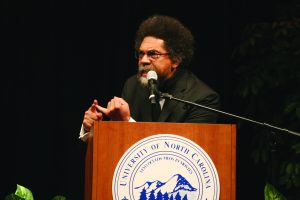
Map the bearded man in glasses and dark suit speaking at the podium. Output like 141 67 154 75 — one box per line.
80 15 220 140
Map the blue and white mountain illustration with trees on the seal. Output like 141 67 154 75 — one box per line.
134 174 197 199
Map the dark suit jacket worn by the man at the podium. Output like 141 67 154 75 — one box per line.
122 69 220 123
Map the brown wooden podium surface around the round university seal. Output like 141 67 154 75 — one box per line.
85 121 236 200
